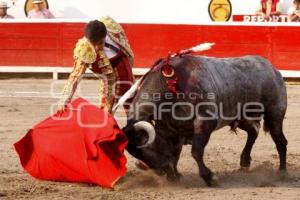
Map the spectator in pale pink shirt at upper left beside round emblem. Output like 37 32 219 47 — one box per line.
28 0 55 19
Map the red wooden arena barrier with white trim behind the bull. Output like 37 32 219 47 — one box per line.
0 19 300 79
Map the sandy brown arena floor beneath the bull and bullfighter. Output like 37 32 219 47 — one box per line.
0 79 300 200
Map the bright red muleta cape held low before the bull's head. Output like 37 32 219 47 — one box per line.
14 98 127 188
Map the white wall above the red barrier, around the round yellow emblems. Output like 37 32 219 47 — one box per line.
7 0 293 24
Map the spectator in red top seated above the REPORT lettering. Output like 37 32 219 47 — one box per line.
256 0 281 18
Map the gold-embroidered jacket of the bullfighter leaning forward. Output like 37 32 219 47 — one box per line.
61 17 134 113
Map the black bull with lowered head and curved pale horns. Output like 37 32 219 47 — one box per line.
124 55 287 186
